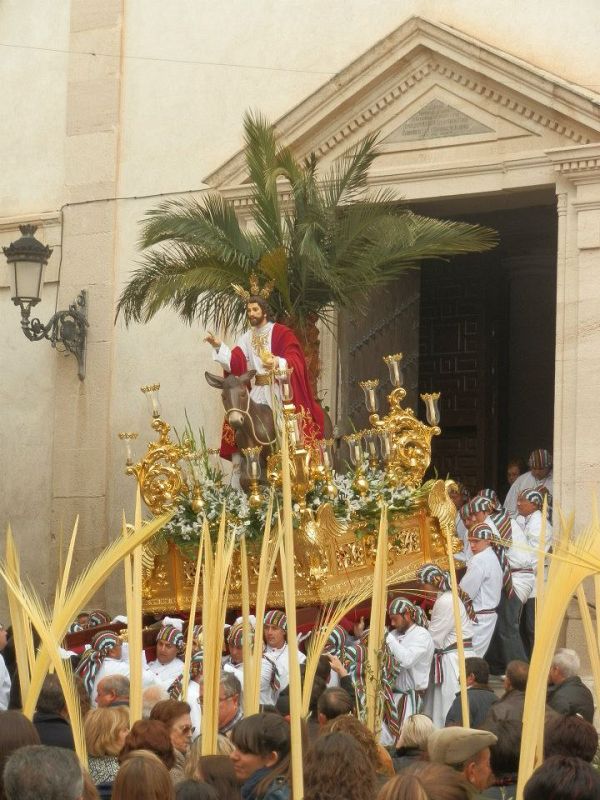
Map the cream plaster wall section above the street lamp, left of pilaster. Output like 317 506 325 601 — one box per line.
0 0 69 217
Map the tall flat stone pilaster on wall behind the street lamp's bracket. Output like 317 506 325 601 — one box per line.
51 0 123 610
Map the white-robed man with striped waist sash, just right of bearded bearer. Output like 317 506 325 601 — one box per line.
417 564 477 728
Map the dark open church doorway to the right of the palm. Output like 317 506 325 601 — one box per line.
419 203 557 491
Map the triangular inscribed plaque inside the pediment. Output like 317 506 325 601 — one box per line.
384 100 492 142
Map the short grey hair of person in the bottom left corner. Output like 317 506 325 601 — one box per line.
4 744 83 800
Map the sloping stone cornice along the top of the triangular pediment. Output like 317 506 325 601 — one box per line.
205 17 600 188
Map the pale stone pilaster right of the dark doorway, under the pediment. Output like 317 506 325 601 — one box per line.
547 144 600 526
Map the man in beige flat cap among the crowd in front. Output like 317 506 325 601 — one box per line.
427 726 498 792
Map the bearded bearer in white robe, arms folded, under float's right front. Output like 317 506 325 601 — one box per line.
386 597 434 726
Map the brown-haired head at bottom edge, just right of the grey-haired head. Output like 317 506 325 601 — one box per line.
112 752 175 800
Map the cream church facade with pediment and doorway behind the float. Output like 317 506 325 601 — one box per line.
0 0 600 611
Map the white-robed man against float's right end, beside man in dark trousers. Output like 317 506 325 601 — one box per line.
459 522 510 658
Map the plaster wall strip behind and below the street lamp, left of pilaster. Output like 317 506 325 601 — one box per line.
0 226 61 622
